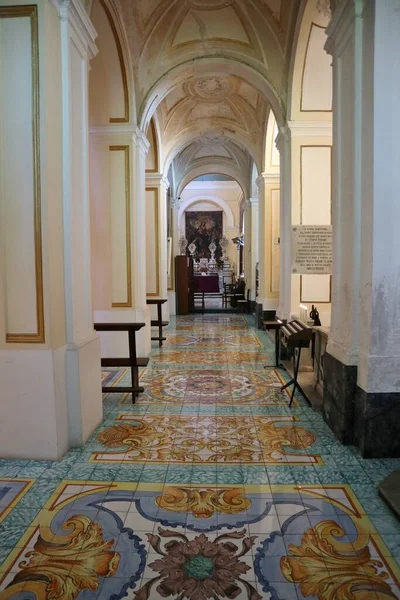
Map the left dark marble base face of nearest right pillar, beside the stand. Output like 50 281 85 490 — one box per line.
323 352 357 444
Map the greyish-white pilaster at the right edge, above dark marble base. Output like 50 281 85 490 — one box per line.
358 0 400 396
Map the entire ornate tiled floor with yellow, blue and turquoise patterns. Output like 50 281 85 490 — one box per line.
0 315 400 600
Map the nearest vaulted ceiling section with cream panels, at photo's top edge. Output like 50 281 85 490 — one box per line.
120 0 301 118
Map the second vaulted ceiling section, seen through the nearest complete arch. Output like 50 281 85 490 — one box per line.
157 74 268 172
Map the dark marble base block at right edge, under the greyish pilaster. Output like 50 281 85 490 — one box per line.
354 387 400 458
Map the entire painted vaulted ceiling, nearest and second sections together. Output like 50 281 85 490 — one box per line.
95 0 304 182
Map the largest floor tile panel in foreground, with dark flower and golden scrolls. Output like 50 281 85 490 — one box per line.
0 481 400 600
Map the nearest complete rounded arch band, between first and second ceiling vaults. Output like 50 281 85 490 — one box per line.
139 56 285 130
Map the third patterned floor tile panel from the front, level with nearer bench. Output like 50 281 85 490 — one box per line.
134 369 297 406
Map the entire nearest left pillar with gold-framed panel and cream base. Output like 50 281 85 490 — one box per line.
0 0 102 459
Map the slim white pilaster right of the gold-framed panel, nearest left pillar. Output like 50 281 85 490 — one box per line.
60 0 102 445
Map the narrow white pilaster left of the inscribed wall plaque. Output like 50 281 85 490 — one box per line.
276 125 292 320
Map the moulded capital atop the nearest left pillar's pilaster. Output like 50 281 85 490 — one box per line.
50 0 98 60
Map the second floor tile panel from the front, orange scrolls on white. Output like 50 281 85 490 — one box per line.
90 414 323 465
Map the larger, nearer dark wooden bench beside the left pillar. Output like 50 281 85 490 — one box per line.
93 323 149 404
